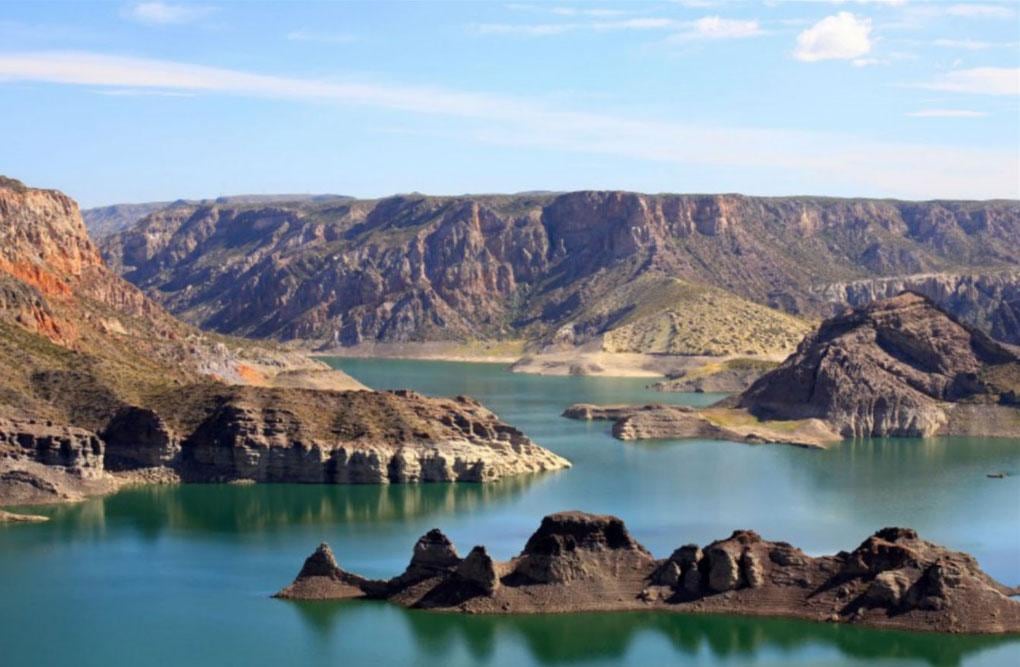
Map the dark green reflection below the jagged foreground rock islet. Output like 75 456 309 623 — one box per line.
285 601 1020 667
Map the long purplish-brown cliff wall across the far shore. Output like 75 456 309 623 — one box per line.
103 192 1020 345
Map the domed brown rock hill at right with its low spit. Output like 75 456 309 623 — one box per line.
564 292 1020 446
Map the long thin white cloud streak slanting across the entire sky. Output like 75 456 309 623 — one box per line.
0 51 1020 197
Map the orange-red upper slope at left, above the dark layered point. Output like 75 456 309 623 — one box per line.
0 178 359 429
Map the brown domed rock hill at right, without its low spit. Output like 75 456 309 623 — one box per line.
737 293 1020 437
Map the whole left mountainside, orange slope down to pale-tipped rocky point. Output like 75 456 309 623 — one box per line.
0 177 568 504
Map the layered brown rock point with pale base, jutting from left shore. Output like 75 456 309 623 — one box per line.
178 388 569 483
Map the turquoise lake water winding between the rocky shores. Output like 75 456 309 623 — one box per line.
0 360 1020 667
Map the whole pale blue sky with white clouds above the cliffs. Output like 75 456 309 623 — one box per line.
0 0 1020 207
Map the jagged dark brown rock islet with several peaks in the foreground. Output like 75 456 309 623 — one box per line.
277 512 1020 633
